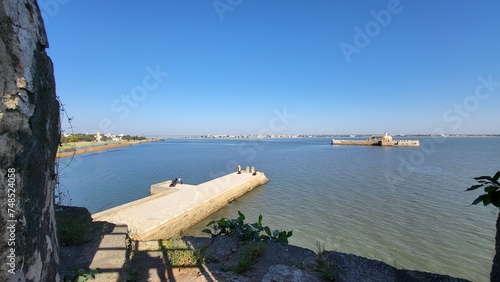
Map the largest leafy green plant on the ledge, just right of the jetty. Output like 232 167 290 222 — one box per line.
202 211 293 245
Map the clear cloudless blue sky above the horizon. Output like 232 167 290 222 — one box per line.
39 0 500 135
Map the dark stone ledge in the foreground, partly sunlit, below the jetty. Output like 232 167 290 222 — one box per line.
56 207 467 282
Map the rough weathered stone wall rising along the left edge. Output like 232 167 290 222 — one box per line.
0 0 60 281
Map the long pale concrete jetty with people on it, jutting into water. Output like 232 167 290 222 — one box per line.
92 169 269 241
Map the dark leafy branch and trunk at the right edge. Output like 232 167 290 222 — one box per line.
467 171 500 281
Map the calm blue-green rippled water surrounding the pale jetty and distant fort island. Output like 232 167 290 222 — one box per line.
60 138 500 281
